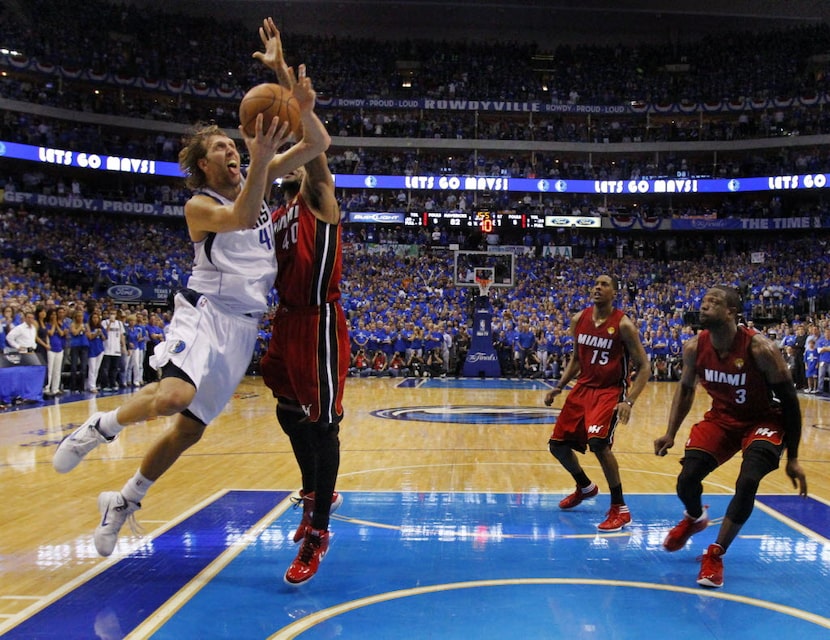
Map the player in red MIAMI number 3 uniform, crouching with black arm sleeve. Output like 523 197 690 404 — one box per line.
654 286 807 587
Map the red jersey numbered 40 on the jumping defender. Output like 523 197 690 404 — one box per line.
272 194 343 307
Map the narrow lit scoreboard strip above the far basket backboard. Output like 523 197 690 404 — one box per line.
404 210 602 233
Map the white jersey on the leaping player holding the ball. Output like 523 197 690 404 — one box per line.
187 182 277 314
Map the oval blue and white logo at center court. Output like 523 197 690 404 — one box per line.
372 405 559 424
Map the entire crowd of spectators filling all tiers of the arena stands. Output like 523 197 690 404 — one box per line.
0 0 830 396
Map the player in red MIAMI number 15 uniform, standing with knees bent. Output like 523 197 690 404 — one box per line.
545 275 649 531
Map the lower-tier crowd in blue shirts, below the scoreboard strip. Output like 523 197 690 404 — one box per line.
0 199 830 396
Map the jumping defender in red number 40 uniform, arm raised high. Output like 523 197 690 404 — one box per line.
255 18 349 585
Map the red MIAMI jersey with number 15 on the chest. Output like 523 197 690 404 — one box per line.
574 307 629 388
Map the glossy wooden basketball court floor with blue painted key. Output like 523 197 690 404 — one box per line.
0 377 830 640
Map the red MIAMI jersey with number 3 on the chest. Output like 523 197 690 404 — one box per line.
695 325 780 423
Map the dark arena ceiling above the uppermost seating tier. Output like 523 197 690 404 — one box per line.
138 0 830 48
